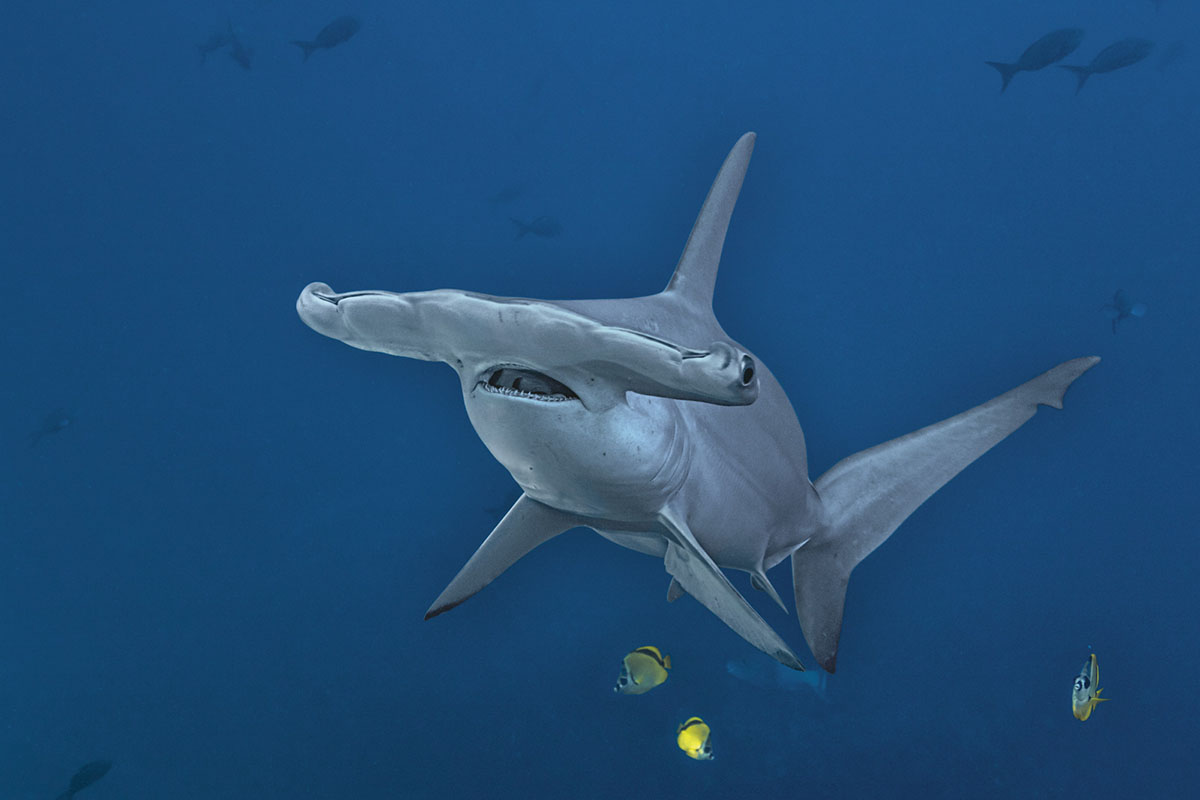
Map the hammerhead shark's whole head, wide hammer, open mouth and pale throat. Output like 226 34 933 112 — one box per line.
296 283 758 519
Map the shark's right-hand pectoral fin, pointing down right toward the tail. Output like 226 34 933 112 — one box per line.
659 515 804 670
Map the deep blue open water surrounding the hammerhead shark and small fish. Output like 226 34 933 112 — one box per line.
0 0 1200 800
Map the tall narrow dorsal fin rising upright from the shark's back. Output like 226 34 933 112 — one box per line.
666 133 755 309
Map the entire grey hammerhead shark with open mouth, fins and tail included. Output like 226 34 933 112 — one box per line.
296 133 1099 672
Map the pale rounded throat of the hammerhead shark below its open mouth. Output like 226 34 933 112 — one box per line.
463 386 690 520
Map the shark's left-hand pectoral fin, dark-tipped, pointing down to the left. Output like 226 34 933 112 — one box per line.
425 494 582 619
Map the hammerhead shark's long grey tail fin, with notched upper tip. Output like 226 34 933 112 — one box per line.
792 356 1099 672
